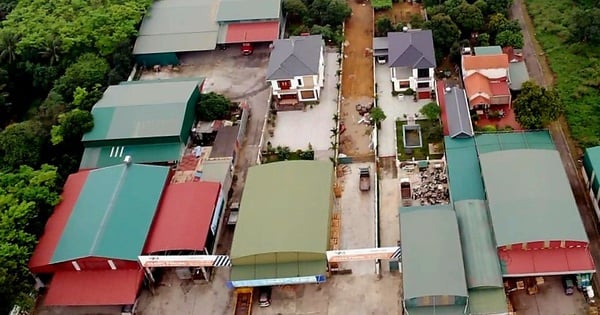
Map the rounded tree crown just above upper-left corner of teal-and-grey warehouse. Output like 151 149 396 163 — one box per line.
53 53 110 102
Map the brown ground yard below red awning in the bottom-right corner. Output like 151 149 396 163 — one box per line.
510 276 586 315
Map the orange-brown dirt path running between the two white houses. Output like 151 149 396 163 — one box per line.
340 0 374 159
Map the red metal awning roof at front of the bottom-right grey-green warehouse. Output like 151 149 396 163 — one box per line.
498 247 595 276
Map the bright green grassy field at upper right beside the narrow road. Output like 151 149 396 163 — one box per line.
526 0 600 147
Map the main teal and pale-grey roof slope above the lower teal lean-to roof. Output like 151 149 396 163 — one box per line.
82 79 203 143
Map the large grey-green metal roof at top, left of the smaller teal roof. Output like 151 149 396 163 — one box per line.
133 0 219 55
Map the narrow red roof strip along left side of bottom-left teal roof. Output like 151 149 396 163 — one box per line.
29 171 90 273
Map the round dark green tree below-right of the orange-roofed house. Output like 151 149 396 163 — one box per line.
513 81 564 129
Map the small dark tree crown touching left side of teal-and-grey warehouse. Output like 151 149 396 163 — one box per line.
50 108 94 145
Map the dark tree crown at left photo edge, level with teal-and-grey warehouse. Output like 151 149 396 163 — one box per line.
0 120 47 169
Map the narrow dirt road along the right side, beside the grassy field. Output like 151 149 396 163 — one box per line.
511 0 600 287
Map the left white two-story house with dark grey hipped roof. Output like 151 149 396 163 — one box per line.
267 35 325 110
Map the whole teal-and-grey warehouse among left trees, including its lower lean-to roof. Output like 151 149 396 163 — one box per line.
79 79 203 169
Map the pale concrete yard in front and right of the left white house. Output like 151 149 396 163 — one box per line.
265 48 339 160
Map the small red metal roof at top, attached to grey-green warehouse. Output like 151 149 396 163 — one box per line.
225 22 279 44
